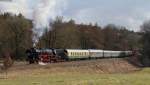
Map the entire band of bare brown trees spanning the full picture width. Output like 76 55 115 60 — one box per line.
0 13 150 66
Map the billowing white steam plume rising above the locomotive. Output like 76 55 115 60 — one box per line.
33 0 66 34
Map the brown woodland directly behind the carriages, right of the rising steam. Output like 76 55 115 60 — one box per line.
37 17 141 50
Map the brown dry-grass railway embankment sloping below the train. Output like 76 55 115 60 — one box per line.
9 58 140 73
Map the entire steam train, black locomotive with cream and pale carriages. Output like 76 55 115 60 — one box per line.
26 48 133 64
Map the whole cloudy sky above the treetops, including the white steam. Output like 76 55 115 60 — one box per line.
0 0 150 31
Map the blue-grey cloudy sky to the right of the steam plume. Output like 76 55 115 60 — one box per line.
64 0 150 31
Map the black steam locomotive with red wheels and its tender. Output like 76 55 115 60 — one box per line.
26 48 68 64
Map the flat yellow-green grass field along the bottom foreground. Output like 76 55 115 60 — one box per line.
0 68 150 85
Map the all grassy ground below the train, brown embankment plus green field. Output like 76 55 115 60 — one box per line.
0 59 146 85
